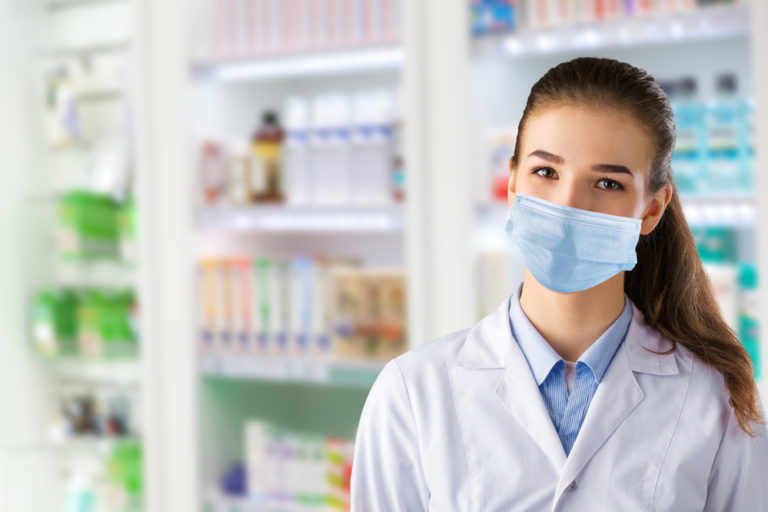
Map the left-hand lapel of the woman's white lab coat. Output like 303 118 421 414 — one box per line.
457 296 565 473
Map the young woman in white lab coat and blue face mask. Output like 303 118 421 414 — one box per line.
352 58 768 512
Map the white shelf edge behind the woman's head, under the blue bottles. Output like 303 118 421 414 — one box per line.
477 196 757 229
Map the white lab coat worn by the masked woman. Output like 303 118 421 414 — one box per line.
351 296 768 512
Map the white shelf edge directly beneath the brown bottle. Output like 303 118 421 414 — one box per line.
195 205 404 233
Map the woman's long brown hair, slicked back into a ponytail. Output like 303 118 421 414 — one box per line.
512 57 763 436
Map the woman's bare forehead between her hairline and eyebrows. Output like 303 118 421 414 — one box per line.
520 105 653 172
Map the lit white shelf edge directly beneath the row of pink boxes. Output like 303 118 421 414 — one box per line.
192 46 404 82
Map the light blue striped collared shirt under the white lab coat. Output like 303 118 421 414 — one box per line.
509 284 632 454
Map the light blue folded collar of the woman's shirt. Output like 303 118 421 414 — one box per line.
509 284 632 386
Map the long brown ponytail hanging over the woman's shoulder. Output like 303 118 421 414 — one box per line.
624 190 763 436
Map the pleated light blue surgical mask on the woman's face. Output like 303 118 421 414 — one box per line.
505 194 642 293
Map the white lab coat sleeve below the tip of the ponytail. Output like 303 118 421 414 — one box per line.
704 410 768 512
